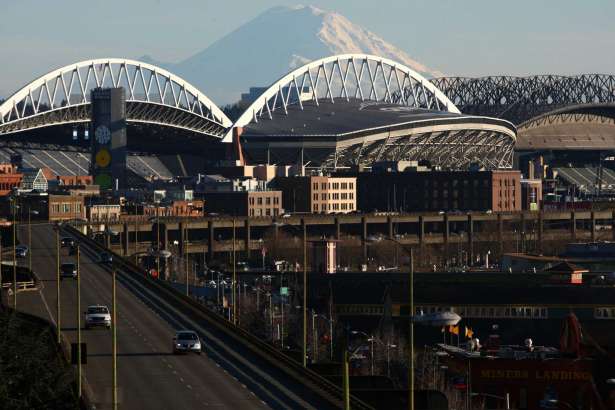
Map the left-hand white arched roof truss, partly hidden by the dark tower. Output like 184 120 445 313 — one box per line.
0 59 231 139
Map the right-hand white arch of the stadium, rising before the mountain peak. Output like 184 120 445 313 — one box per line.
223 54 460 142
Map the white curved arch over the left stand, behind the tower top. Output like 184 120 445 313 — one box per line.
0 58 232 133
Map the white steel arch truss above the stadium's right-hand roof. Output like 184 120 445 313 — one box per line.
227 54 459 139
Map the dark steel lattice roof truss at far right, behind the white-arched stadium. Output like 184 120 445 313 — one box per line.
430 74 615 125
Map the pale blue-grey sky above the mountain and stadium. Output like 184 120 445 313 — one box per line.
0 0 615 98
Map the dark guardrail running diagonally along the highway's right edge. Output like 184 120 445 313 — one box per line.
65 225 373 410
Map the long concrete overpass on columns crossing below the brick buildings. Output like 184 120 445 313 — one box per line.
86 210 615 268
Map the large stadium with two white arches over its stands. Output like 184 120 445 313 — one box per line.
0 54 516 179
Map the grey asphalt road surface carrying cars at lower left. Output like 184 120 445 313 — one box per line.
18 225 278 409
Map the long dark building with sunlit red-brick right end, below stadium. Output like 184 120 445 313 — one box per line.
357 170 521 212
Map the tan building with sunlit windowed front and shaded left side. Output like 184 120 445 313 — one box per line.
272 176 357 214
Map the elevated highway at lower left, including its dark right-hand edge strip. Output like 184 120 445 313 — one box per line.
18 225 368 409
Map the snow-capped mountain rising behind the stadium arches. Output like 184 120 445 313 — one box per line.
142 6 441 106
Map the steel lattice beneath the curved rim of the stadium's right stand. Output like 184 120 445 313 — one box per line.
322 129 514 170
